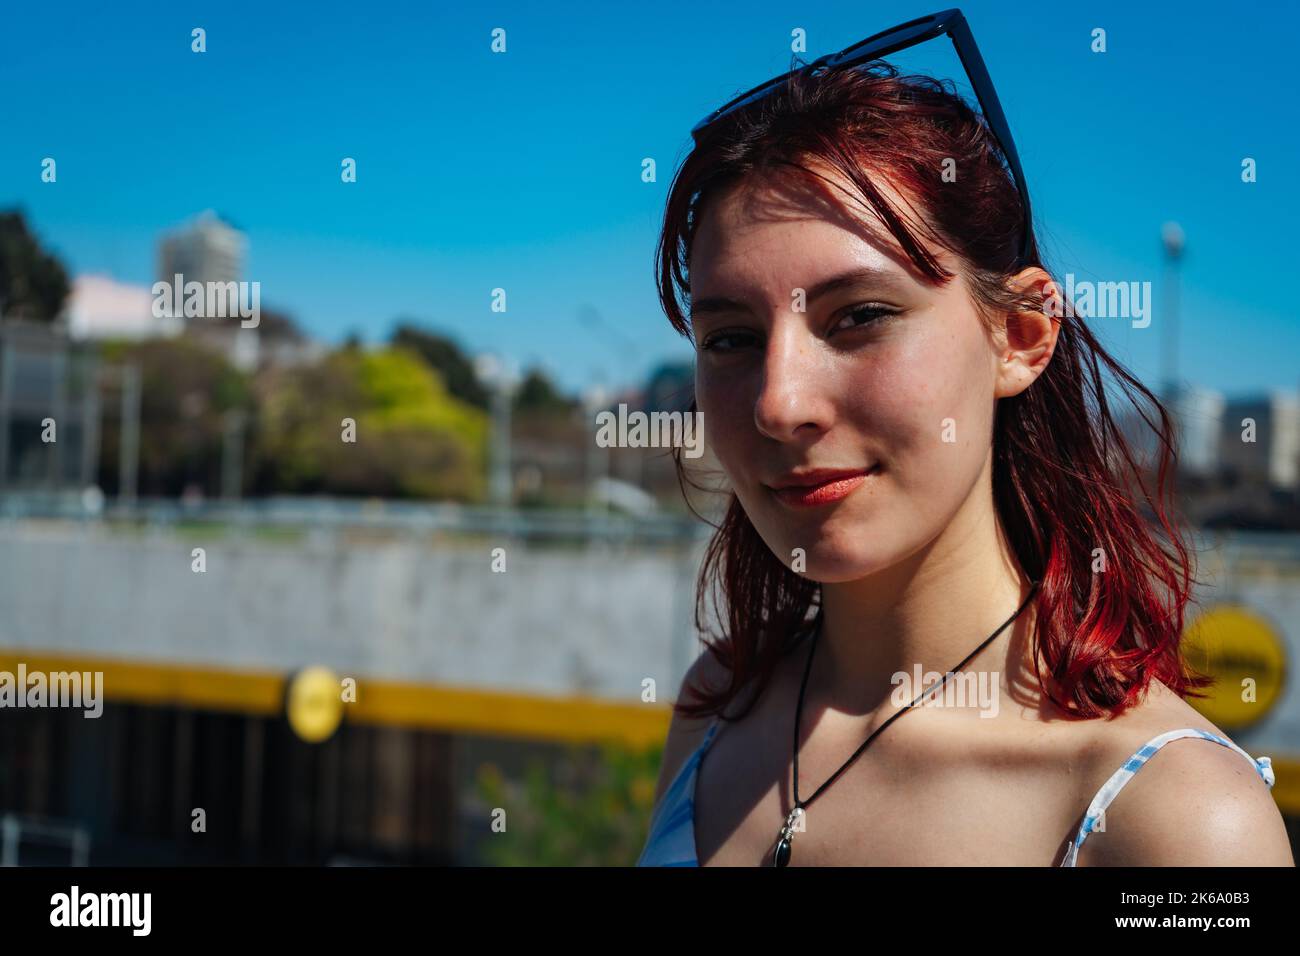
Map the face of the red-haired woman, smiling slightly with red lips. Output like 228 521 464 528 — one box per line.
689 165 1019 583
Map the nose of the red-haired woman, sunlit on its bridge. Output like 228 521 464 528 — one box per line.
754 326 831 441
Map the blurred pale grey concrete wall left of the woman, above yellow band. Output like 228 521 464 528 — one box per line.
0 522 702 701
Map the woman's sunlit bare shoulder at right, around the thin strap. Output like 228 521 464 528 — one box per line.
1079 682 1295 866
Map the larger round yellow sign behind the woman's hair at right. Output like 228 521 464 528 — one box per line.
1183 605 1287 730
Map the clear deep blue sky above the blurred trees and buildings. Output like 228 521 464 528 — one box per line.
0 0 1300 393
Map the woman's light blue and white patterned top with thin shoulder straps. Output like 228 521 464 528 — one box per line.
637 721 1274 866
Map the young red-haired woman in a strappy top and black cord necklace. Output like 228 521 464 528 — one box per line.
640 50 1295 866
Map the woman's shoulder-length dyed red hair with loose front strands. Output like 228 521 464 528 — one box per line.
655 61 1212 718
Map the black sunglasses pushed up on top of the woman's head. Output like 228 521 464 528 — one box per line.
690 8 1032 264
